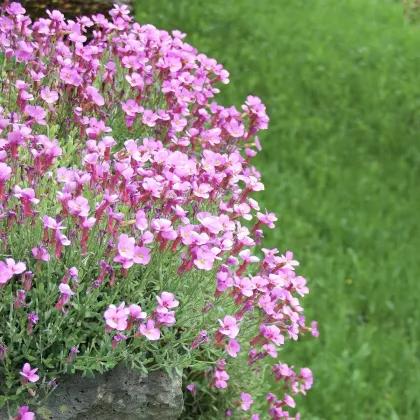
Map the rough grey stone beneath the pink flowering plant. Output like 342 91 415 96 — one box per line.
0 367 184 420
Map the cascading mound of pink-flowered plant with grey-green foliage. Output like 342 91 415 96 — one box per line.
0 3 318 420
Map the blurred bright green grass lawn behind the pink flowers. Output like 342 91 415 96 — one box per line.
137 0 420 420
